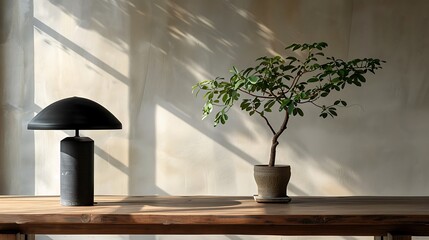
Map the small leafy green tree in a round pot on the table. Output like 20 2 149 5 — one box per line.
192 42 384 202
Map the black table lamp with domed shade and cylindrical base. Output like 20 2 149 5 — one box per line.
28 97 122 206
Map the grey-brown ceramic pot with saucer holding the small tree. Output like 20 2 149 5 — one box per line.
254 165 291 202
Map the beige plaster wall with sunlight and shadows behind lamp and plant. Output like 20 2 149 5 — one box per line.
0 0 429 239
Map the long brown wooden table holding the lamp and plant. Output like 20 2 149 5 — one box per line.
0 196 429 240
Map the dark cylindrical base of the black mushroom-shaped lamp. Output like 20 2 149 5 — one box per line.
60 136 94 206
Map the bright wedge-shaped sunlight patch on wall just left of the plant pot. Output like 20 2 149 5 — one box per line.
155 105 255 195
